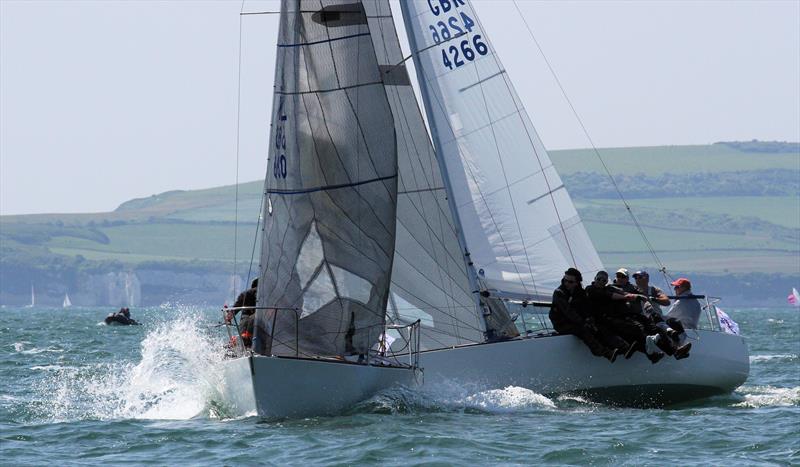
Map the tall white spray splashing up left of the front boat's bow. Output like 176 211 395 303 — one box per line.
37 310 238 422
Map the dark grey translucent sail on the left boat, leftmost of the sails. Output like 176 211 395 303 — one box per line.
253 0 397 356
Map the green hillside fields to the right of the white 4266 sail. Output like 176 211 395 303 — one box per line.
551 142 800 275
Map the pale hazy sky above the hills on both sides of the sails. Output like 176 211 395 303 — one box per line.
0 0 800 215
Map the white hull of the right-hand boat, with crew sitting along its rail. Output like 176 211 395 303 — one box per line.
420 331 750 406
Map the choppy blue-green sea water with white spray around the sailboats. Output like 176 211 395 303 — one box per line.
0 307 800 465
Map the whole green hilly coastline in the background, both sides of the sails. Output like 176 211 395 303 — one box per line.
0 142 800 302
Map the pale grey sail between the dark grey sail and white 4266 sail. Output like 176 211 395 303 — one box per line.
364 0 484 349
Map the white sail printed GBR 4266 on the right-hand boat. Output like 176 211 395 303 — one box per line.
401 0 602 297
